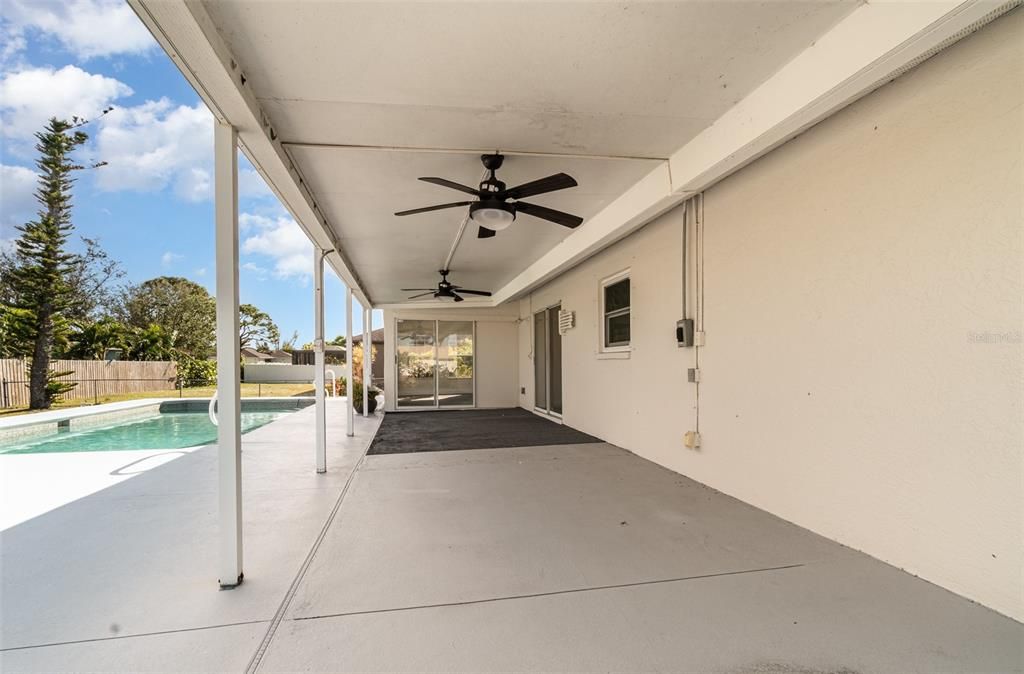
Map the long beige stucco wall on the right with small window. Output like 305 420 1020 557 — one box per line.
518 10 1024 620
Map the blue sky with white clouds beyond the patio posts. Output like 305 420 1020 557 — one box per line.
0 0 381 343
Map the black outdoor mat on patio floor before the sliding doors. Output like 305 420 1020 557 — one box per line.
367 408 601 454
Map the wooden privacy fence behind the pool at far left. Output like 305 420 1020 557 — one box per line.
0 359 178 408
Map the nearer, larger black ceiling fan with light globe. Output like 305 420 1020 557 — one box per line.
395 154 583 239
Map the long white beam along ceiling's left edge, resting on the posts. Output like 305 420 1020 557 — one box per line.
127 0 370 305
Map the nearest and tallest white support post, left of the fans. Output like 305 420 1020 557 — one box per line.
213 123 243 588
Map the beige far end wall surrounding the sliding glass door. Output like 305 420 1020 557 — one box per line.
384 305 518 410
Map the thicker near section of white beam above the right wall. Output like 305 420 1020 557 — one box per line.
669 0 1020 194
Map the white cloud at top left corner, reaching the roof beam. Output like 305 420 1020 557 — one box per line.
3 0 157 58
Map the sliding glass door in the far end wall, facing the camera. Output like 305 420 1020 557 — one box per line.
396 320 475 409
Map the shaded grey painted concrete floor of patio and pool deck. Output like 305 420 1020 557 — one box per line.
0 401 1024 673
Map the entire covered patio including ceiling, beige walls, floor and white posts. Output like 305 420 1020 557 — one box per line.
0 0 1024 673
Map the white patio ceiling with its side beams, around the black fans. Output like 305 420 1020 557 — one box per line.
130 0 998 306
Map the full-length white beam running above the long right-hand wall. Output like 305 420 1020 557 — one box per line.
491 0 1020 301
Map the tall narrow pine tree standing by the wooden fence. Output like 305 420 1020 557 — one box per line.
8 118 88 410
